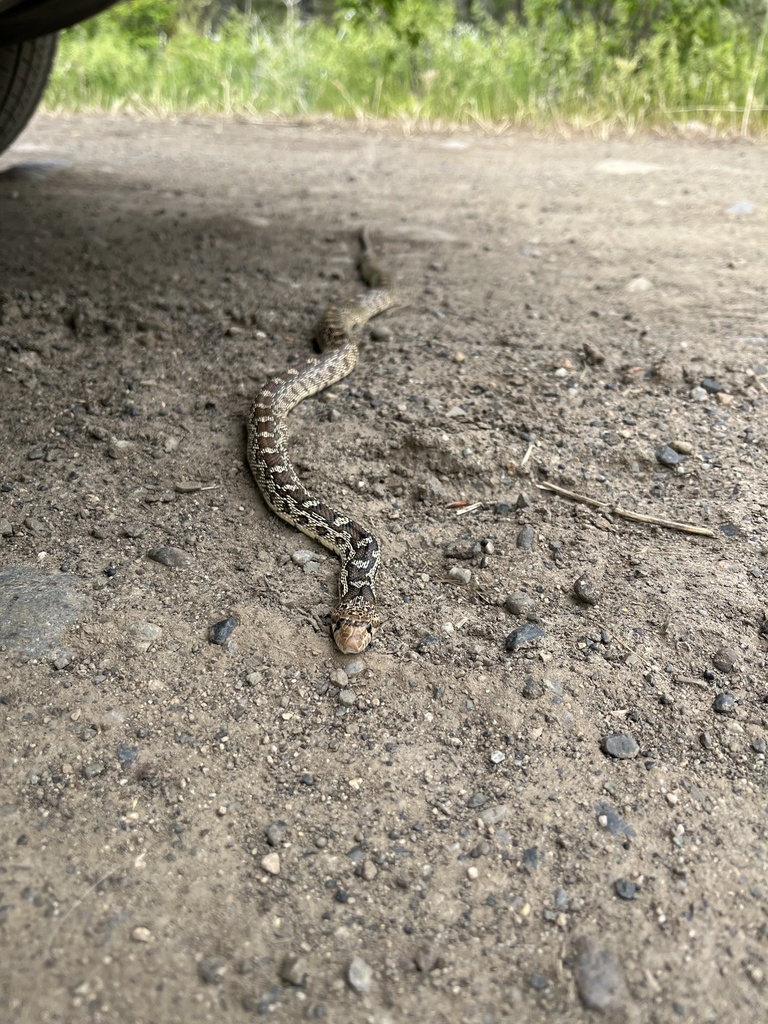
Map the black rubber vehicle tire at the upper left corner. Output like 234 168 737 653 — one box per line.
0 36 56 153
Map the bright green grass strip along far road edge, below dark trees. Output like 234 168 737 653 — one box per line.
45 7 768 133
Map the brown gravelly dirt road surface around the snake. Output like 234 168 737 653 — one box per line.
0 117 768 1024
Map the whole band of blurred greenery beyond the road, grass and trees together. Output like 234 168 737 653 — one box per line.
47 0 768 133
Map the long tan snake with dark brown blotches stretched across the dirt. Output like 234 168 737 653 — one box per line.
248 228 395 654
